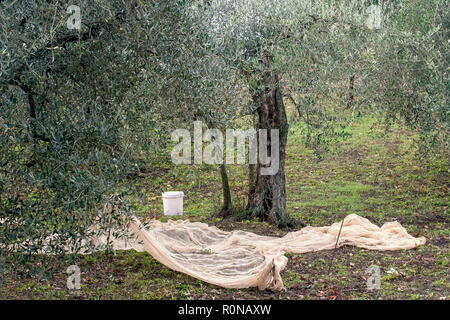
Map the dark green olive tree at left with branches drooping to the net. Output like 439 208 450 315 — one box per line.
0 0 202 253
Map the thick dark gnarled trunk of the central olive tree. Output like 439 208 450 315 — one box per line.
247 52 291 226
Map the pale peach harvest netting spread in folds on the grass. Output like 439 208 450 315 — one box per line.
114 214 426 290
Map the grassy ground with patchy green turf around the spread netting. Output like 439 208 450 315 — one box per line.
0 115 450 299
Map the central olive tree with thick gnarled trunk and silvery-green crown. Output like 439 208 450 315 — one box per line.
192 1 380 225
